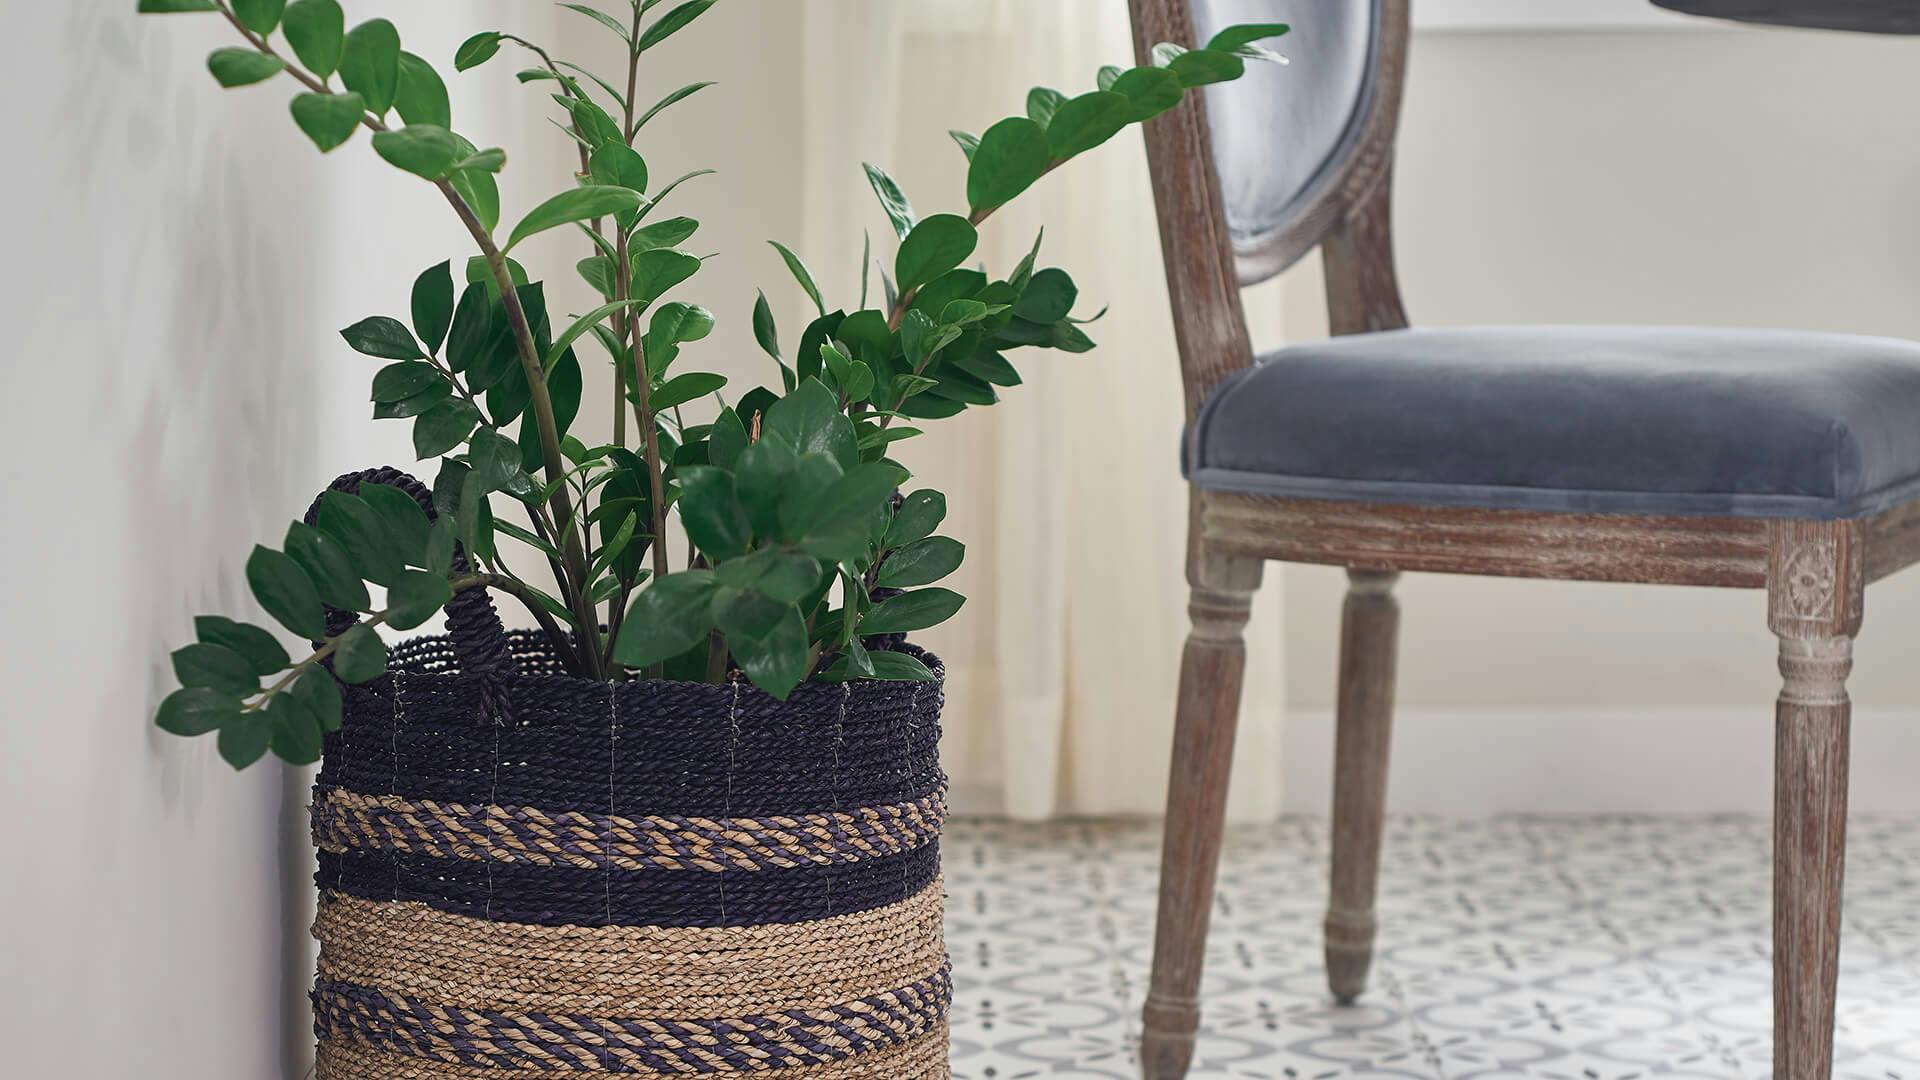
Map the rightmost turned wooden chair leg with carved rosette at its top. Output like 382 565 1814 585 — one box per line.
1766 521 1862 1080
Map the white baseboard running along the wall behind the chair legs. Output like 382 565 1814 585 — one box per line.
1283 707 1920 817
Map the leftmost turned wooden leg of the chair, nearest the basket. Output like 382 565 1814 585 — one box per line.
1140 552 1263 1080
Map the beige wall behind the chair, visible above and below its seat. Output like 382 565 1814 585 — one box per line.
1284 29 1920 711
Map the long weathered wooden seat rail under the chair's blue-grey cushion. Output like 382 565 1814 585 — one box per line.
1200 492 1766 588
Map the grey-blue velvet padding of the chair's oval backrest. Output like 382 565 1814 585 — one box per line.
1192 0 1380 276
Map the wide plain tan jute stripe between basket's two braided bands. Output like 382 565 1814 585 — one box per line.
313 880 947 1019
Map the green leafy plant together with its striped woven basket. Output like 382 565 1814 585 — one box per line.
140 0 1286 1080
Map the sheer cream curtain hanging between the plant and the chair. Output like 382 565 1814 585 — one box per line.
801 0 1284 821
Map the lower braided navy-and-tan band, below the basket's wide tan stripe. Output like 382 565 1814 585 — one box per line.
313 967 952 1072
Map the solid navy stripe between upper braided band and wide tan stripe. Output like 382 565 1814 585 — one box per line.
313 842 941 926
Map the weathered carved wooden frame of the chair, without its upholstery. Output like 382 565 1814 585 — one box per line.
1131 0 1920 1080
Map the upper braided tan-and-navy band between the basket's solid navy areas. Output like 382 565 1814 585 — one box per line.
313 788 947 871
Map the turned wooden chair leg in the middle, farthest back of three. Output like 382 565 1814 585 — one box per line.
1327 571 1400 1005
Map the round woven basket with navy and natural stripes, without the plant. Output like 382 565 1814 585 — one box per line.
313 471 950 1080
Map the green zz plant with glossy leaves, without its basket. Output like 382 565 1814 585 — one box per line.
140 0 1286 769
